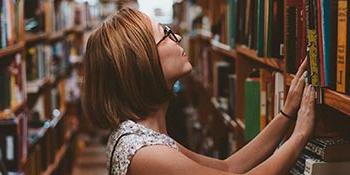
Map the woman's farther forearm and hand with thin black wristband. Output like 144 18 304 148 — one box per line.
226 59 307 173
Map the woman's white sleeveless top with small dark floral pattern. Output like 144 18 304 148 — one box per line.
106 120 178 175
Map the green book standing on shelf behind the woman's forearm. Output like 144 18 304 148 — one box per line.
244 78 260 141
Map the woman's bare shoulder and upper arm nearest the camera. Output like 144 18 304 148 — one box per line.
128 145 242 175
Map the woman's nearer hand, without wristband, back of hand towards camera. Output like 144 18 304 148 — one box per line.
293 85 315 139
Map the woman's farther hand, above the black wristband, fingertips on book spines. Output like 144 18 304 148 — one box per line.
283 58 307 116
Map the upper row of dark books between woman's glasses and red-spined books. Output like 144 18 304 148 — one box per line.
197 0 284 58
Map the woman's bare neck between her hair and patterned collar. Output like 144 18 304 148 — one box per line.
137 102 169 134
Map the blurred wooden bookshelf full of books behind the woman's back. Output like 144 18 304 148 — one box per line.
0 0 105 175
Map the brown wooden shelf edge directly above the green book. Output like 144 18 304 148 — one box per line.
236 45 284 72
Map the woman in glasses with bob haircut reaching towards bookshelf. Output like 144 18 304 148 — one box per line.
83 9 315 175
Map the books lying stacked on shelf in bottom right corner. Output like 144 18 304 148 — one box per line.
290 137 350 175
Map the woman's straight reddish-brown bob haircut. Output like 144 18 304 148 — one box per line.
82 8 172 128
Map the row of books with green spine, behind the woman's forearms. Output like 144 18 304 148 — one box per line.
213 61 284 140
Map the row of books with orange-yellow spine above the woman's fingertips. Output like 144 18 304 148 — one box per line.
285 0 350 94
